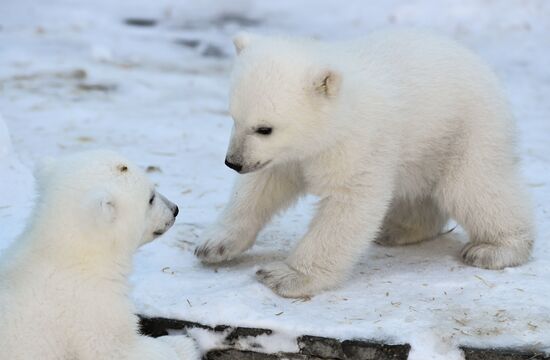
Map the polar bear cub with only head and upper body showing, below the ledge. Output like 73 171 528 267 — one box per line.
0 151 200 360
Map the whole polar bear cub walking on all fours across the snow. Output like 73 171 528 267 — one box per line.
196 30 533 297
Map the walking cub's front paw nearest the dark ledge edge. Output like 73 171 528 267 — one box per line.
256 261 319 298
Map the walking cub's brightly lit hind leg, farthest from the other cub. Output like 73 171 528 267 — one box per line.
438 161 534 269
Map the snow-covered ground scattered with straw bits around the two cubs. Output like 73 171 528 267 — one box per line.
0 0 550 359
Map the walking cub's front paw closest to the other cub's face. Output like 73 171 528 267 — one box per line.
195 229 253 264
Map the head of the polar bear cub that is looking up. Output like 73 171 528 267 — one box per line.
31 150 178 252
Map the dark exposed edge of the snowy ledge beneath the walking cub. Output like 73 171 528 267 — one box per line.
140 316 550 360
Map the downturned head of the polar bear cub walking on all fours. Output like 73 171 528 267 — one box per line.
225 34 341 173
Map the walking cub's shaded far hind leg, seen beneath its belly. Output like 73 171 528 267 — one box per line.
376 197 448 246
